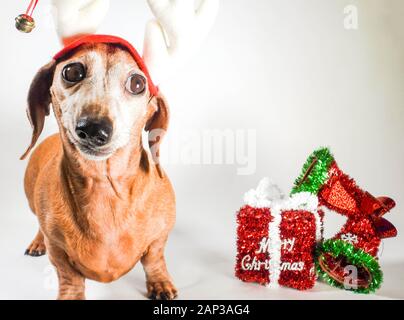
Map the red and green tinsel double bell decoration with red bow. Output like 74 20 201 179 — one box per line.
292 148 397 293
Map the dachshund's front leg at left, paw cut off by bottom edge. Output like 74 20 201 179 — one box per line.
48 245 85 300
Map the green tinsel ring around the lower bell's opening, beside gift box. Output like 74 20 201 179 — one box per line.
316 239 383 293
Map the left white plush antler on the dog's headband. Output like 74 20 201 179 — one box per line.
52 0 109 41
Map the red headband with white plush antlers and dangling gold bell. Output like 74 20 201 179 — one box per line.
16 0 219 90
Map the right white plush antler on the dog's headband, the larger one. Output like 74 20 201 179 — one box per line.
143 0 219 84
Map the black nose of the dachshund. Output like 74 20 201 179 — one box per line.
76 118 112 147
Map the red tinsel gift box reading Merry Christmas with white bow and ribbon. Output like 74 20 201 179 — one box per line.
235 178 322 290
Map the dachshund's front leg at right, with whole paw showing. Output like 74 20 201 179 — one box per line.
141 238 177 300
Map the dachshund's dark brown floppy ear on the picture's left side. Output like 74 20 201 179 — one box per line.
20 60 56 160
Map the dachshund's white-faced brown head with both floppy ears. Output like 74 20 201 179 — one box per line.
22 36 168 172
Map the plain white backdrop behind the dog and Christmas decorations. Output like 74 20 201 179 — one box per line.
0 0 404 299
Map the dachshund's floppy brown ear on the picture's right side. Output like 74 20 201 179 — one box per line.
145 94 170 178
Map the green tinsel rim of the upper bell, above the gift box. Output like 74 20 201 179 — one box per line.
291 148 334 195
